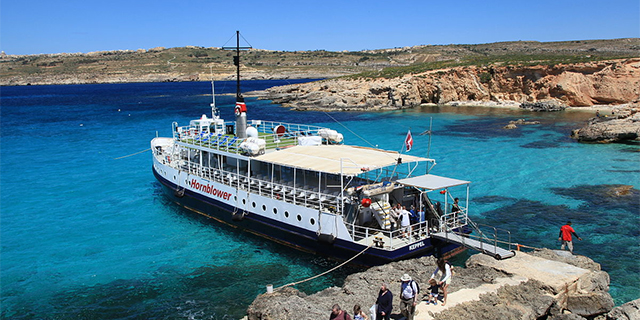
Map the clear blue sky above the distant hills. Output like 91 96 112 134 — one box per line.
0 0 640 54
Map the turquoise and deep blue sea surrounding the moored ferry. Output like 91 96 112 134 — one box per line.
0 80 640 319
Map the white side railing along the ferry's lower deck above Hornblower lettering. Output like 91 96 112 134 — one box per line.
178 163 342 214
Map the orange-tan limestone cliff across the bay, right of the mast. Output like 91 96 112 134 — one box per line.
266 58 640 110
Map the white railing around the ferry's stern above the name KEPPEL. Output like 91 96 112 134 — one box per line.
347 221 437 250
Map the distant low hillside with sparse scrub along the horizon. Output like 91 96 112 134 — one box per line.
0 38 640 83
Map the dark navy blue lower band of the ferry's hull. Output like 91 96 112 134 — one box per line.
153 168 459 266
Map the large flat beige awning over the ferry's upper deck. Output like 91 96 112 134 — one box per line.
254 145 431 175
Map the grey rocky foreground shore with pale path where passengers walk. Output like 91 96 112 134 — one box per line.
246 249 640 320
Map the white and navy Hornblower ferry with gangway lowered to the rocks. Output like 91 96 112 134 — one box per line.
151 31 515 266
